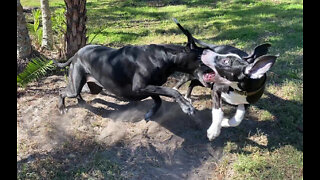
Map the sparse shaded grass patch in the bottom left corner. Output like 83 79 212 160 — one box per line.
17 152 121 179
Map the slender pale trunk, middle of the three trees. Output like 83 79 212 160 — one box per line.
40 0 53 50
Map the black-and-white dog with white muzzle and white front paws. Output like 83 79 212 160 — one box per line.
172 22 277 140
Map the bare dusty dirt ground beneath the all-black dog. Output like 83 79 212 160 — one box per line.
17 75 239 179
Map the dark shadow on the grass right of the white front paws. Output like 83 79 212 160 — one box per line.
214 92 303 154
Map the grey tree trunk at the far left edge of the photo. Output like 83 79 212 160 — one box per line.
17 0 32 59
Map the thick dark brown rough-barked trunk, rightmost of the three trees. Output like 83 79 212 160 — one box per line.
64 0 87 59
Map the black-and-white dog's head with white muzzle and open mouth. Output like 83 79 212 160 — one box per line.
201 45 277 88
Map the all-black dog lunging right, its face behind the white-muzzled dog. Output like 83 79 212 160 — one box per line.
55 22 203 120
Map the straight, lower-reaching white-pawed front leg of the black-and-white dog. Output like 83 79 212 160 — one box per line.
207 86 223 141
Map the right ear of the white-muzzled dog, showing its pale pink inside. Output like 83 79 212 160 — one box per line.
244 55 277 79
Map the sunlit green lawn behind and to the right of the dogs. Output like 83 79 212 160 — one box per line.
21 0 303 179
